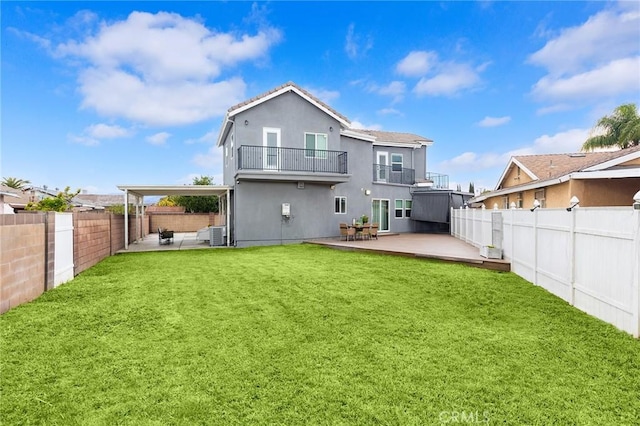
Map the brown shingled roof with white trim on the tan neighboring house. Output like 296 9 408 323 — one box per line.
472 145 640 202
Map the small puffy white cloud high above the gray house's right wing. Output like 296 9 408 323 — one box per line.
413 62 480 96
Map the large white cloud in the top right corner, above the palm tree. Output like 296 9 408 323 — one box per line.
528 2 640 106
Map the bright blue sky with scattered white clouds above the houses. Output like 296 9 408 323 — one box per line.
0 1 640 193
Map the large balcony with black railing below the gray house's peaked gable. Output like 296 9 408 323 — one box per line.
236 145 351 184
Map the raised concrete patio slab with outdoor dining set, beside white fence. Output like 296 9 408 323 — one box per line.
307 234 511 271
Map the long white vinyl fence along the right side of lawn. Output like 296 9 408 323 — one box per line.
451 207 640 337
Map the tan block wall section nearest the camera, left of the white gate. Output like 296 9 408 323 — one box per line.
0 213 45 313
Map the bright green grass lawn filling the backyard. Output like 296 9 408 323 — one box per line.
0 245 640 425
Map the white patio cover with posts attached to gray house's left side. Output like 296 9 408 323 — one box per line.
118 185 232 250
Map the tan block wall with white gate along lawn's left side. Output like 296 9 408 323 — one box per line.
0 212 149 314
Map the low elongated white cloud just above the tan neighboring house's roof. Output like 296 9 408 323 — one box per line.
438 129 589 173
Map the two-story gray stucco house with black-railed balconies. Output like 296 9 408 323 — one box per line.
218 83 448 247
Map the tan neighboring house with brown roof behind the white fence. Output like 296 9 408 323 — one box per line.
471 146 640 209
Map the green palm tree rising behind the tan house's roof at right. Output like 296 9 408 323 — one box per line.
582 104 640 151
